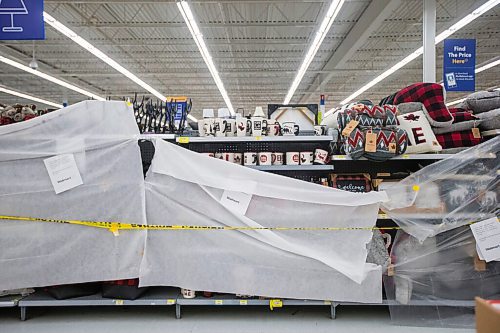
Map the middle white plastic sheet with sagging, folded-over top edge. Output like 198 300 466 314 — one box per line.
140 141 387 302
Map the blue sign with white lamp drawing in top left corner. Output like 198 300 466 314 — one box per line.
0 0 45 40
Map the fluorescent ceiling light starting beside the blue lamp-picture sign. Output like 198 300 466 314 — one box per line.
43 12 197 121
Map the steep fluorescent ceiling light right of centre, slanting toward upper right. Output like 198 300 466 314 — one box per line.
283 0 344 104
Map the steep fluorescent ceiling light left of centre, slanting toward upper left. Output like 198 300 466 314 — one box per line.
177 0 235 116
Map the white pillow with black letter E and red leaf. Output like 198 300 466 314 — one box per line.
398 111 442 154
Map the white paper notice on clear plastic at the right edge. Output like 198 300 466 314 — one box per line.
470 217 500 262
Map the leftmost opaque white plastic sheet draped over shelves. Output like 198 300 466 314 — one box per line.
0 101 146 290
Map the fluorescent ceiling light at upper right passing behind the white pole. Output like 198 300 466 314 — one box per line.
340 0 500 104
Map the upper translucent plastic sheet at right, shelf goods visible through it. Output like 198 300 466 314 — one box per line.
382 137 500 242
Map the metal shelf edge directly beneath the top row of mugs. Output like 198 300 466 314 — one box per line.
176 135 333 143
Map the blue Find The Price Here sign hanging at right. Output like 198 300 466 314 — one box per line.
443 39 476 91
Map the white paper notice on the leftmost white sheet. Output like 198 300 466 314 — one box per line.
43 154 83 194
